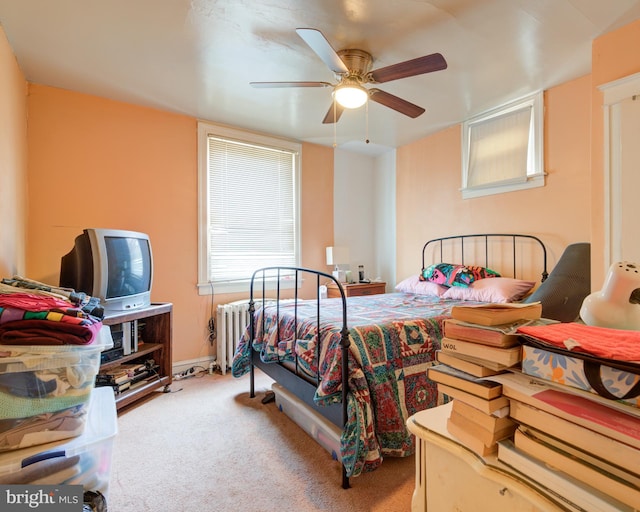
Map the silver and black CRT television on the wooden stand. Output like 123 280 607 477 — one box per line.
60 228 153 315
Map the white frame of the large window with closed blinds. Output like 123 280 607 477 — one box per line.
197 121 302 295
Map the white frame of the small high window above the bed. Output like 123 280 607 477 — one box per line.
461 91 545 199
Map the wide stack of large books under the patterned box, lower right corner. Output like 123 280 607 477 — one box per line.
495 372 640 511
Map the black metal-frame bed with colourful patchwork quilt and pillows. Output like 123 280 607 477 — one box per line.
232 234 548 488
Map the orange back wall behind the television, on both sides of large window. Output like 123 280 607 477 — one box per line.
27 85 333 361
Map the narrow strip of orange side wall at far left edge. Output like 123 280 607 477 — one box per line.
0 26 27 277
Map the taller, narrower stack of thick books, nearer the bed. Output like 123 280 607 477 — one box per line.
427 303 542 457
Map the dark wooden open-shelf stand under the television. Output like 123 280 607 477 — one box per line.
100 302 173 410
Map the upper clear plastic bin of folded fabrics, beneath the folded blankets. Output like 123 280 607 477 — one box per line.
0 328 113 452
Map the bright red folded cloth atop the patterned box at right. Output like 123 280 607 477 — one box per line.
518 322 640 361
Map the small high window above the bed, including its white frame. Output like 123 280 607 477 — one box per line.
462 93 544 199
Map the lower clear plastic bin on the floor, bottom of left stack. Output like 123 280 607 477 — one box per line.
0 388 118 497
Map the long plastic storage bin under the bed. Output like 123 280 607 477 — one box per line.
271 384 342 461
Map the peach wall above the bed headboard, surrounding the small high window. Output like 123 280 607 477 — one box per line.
396 76 591 280
